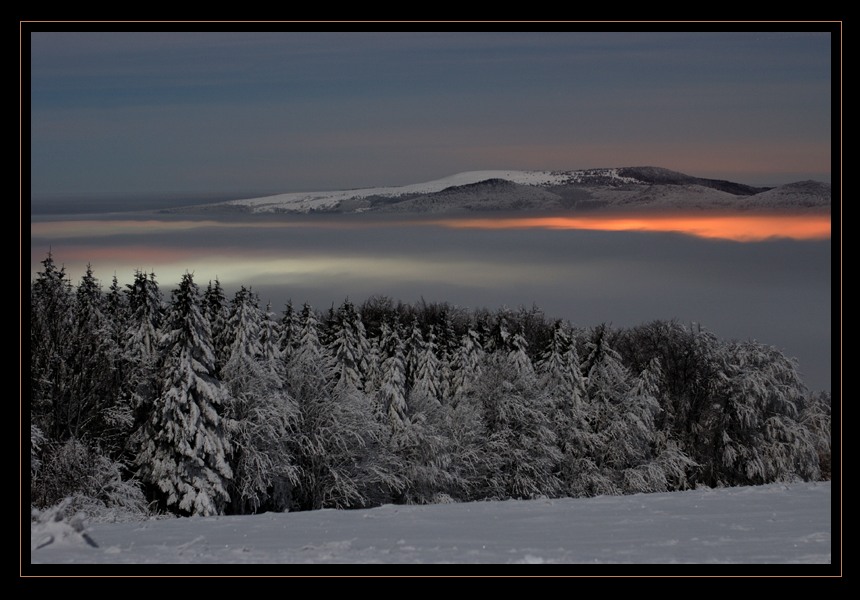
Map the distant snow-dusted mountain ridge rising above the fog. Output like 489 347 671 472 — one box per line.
171 167 831 213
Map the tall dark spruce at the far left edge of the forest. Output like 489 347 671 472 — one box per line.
30 252 74 440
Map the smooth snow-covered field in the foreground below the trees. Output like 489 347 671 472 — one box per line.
22 482 841 575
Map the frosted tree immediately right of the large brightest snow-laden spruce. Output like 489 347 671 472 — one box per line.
221 286 297 513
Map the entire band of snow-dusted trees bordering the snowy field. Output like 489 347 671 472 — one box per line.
29 253 831 518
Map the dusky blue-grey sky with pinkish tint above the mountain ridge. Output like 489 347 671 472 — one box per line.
28 25 832 197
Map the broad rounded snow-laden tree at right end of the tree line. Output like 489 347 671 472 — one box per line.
703 341 820 486
